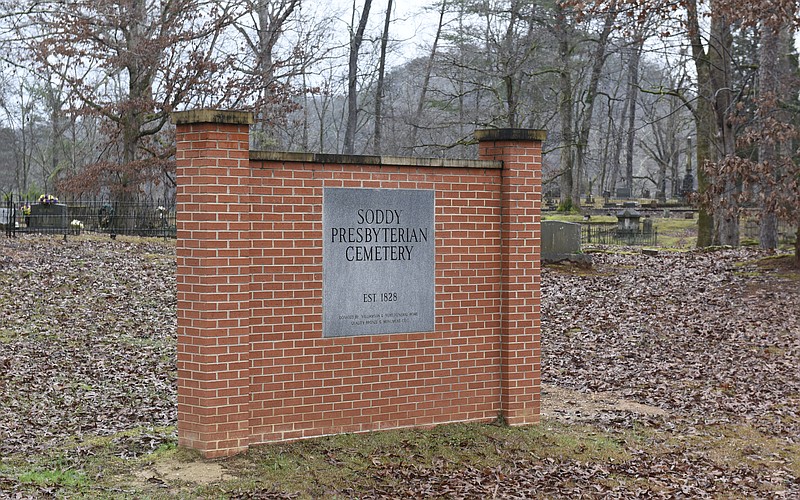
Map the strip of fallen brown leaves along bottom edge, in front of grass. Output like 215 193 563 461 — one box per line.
360 453 788 499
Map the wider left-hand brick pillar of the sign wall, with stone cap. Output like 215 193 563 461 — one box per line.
172 110 253 458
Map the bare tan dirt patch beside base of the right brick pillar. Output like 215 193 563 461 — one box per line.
542 384 669 422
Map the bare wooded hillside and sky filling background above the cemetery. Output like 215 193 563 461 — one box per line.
0 0 800 254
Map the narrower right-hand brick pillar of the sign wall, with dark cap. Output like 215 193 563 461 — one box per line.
475 129 546 425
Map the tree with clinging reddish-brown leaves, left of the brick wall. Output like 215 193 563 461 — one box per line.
3 0 241 205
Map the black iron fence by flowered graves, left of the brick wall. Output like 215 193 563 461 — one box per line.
0 196 176 238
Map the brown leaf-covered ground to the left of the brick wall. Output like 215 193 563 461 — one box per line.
0 237 176 456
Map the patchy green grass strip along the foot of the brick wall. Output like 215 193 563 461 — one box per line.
0 419 800 499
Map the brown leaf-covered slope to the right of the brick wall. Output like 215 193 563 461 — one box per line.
542 251 800 442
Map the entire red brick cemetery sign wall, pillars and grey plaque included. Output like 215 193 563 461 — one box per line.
173 110 544 457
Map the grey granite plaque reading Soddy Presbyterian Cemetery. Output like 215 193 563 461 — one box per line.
322 188 436 337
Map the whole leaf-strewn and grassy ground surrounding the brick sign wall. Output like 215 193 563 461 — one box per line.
0 236 800 498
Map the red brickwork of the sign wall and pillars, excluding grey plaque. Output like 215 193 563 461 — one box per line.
176 115 541 457
